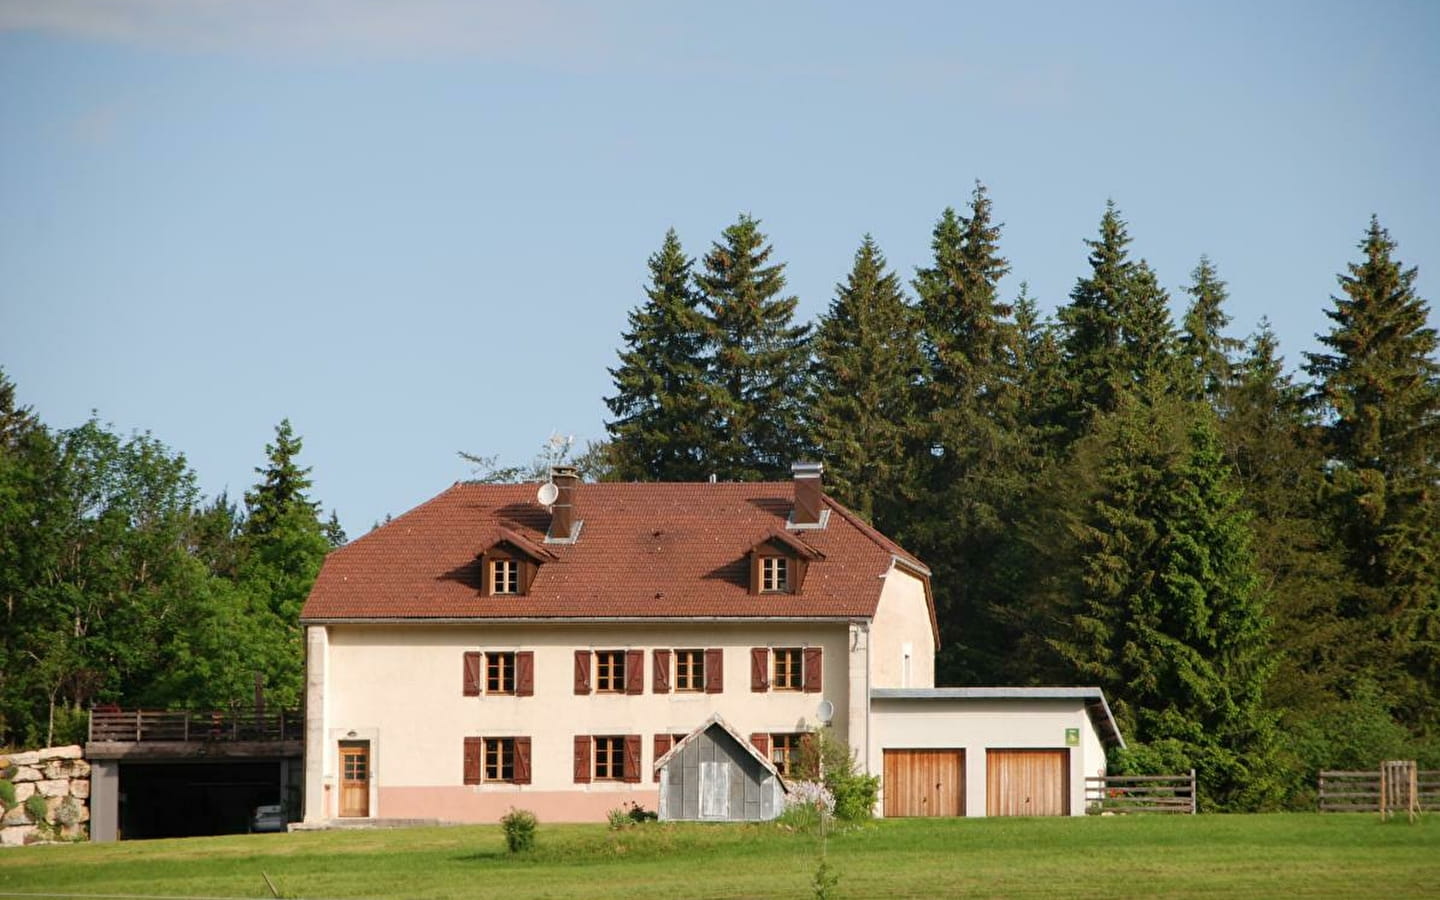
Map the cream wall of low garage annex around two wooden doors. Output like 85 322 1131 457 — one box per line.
870 688 1104 816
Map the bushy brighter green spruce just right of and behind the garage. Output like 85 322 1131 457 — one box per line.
1051 384 1277 808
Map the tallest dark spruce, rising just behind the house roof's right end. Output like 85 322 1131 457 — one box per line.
900 184 1032 681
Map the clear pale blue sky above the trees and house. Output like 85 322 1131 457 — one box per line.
0 0 1440 536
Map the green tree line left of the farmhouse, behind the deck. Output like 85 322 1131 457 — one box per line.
0 391 344 747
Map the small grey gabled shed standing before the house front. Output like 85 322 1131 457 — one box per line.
655 713 789 822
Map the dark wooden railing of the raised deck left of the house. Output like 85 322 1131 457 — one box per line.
89 710 305 743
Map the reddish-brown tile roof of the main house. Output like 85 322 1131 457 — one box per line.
301 482 923 621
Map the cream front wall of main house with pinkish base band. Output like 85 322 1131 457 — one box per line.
305 622 865 821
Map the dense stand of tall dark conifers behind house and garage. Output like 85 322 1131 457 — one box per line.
599 184 1440 809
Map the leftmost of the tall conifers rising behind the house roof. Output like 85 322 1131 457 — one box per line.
605 229 714 481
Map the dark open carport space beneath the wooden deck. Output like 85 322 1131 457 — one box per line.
120 760 281 841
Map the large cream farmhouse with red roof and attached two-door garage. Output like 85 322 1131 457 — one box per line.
301 464 1119 822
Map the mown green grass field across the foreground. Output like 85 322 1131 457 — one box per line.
0 815 1440 900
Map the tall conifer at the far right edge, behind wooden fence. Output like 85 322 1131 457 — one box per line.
1305 217 1440 727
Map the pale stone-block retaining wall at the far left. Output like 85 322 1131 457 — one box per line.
0 744 89 847
